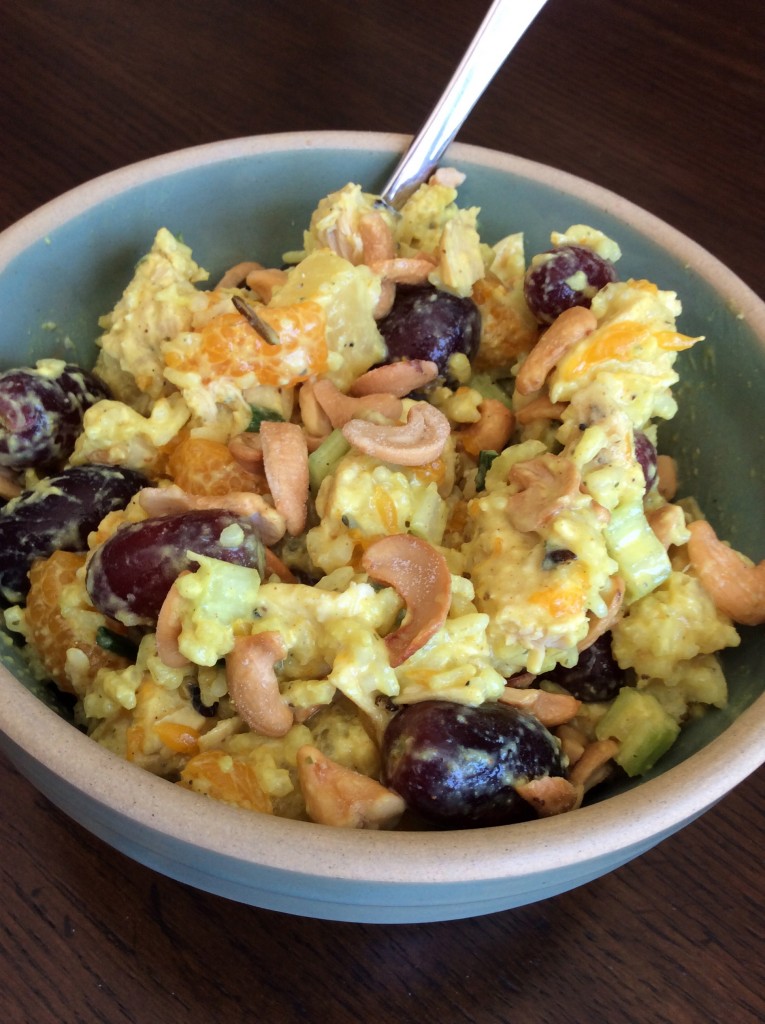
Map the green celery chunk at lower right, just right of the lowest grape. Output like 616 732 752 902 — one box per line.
595 686 680 777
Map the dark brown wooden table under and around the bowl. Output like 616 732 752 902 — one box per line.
0 0 765 1024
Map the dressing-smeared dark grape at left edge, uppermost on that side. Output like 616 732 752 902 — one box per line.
0 360 109 470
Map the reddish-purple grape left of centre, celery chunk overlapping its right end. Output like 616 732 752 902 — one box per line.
86 509 265 626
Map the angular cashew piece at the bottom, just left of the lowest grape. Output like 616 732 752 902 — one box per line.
297 744 406 829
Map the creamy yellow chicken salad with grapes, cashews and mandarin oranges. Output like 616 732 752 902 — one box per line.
0 169 765 828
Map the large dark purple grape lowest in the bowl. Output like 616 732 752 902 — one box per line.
382 700 563 827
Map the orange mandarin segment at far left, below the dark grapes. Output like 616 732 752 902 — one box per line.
27 551 128 693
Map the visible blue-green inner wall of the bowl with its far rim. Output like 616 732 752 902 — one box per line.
0 133 765 811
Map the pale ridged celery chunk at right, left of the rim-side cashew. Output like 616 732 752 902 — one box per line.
604 500 672 601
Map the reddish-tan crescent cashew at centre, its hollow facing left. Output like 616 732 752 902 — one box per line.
362 534 452 668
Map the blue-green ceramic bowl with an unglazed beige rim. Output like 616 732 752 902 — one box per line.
0 133 765 923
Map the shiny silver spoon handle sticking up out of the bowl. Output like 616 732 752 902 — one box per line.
381 0 546 209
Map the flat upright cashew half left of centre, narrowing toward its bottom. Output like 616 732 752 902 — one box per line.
260 422 308 537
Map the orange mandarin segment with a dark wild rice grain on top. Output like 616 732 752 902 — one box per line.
166 301 327 387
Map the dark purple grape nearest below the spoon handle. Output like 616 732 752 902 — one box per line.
378 285 481 374
